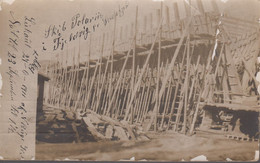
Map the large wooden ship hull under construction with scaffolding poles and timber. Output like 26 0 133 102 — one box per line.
38 0 260 141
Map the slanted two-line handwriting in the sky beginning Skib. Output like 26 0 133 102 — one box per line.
42 1 129 51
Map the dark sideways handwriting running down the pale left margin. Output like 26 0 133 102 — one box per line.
6 11 38 159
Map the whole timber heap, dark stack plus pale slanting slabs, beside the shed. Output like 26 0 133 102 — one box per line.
37 107 149 143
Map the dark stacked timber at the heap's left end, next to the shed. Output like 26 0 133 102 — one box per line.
36 106 86 143
